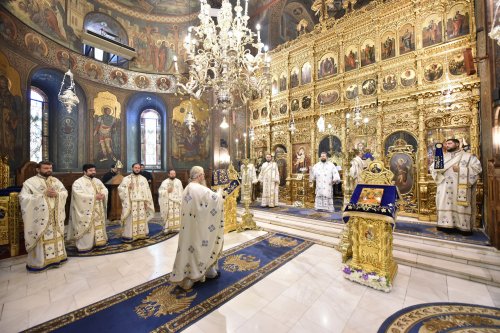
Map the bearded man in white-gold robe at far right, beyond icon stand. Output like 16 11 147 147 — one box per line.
431 139 482 233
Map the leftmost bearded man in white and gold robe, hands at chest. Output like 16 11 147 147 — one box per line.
19 161 68 271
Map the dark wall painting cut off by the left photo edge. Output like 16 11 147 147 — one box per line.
0 52 22 169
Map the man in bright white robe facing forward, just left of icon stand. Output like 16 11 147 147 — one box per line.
309 153 340 212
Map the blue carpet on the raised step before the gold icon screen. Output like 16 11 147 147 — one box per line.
251 201 491 246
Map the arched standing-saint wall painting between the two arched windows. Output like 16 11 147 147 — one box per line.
92 91 123 169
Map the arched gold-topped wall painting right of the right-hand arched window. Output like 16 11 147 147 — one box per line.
172 100 210 168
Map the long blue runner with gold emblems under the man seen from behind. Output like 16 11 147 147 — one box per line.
26 233 313 333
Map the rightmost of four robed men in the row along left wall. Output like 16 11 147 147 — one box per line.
158 170 183 233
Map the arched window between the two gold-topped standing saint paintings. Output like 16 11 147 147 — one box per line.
141 109 161 169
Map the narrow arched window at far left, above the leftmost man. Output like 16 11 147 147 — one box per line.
30 86 49 162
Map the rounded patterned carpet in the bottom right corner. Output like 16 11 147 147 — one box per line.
378 303 500 333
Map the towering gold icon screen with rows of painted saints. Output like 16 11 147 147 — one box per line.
249 1 483 223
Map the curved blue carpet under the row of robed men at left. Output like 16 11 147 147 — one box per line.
66 218 177 257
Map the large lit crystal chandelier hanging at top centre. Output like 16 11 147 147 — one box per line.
174 0 270 105
